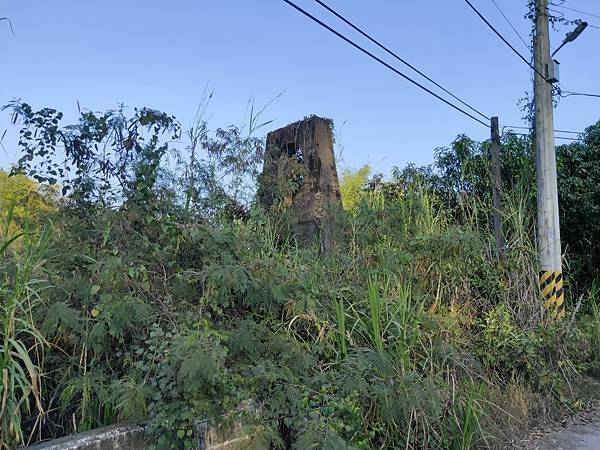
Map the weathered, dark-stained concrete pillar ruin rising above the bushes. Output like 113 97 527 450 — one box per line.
259 116 342 253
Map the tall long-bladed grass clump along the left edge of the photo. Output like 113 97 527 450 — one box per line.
0 206 52 449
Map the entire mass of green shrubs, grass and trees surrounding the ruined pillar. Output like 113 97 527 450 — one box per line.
0 104 600 449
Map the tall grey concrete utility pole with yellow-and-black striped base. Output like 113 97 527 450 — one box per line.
534 0 565 318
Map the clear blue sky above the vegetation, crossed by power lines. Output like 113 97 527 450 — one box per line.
0 0 600 171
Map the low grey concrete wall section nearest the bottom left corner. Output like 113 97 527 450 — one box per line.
27 424 147 450
